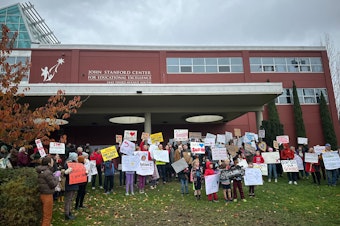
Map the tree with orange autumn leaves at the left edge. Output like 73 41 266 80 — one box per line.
0 25 82 147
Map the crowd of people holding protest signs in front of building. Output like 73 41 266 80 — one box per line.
0 135 340 225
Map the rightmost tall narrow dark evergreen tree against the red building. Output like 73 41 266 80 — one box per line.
319 92 338 149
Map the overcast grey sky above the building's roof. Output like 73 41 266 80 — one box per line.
0 0 340 49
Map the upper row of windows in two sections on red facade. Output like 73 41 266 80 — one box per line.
166 57 323 74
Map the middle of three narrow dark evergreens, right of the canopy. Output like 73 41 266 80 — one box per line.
293 81 306 137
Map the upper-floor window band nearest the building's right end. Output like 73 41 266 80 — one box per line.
249 57 323 73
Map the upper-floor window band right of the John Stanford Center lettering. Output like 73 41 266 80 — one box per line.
166 57 243 74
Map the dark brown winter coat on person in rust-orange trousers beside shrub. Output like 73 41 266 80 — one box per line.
36 166 59 194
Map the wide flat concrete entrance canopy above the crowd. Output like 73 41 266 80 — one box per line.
20 82 283 126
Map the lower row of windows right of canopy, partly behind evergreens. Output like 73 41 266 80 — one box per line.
275 88 328 104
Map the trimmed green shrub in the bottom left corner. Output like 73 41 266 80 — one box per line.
0 167 41 226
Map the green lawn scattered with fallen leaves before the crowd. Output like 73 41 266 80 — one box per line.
52 176 340 226
